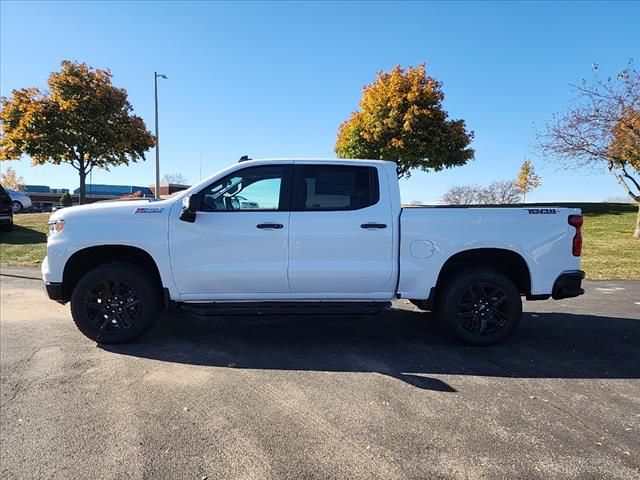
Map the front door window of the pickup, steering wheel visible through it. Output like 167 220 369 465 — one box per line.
202 165 285 211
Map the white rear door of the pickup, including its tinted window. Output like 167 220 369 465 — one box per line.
289 162 395 299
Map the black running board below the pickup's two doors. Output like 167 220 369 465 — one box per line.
179 302 391 316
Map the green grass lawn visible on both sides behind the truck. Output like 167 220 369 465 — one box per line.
0 203 640 280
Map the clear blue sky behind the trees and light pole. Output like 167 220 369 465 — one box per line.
0 1 640 202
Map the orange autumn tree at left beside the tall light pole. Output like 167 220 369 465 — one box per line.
0 60 155 203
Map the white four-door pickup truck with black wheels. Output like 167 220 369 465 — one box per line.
42 159 584 345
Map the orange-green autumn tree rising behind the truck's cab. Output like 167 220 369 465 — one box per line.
335 64 474 177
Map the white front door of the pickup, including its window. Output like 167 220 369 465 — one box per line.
169 164 292 300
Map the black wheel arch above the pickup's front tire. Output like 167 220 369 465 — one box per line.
62 245 163 301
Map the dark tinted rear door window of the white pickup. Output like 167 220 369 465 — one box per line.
294 165 380 210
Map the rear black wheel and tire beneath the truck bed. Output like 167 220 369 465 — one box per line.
437 269 522 345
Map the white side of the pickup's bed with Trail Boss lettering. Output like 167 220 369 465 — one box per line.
398 206 580 298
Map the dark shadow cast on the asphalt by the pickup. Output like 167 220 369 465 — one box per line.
101 309 640 392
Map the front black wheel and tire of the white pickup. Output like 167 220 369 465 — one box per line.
71 263 161 344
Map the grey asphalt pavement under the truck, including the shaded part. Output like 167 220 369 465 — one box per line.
0 268 640 480
